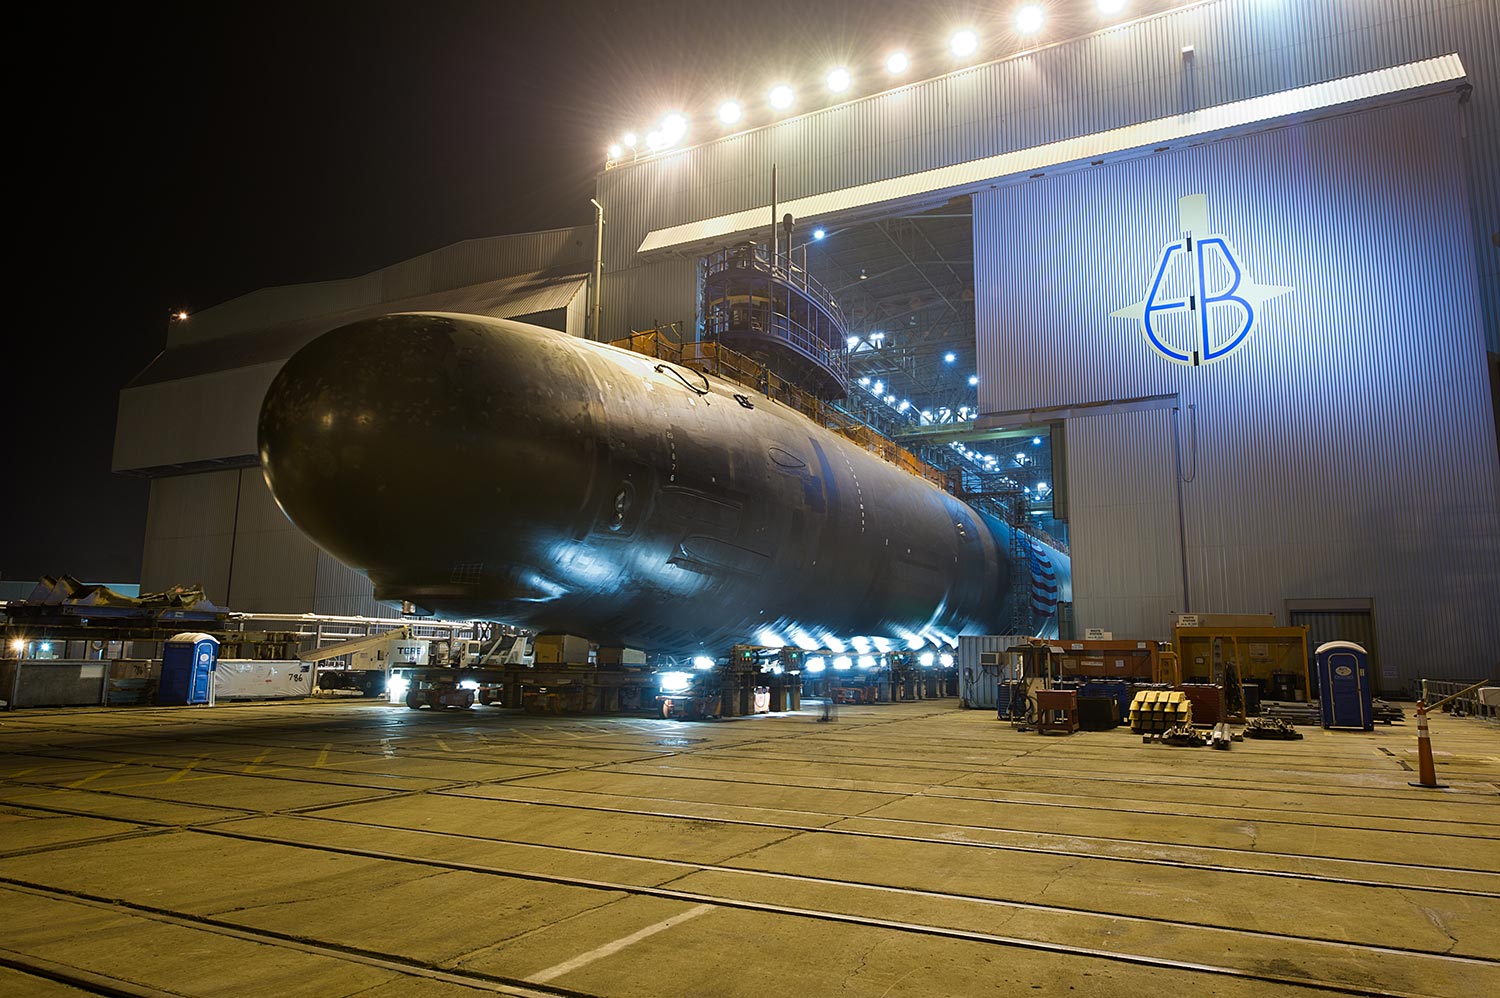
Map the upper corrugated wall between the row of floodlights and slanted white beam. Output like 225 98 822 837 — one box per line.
597 0 1500 350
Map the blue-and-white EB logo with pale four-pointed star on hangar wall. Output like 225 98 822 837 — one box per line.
1110 194 1292 365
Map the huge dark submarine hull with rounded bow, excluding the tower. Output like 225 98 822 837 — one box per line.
260 314 1068 656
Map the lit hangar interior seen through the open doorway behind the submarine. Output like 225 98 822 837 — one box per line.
791 197 1071 635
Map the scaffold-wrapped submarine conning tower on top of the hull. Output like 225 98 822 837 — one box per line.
699 242 849 401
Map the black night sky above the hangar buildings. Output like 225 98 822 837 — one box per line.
0 0 1166 582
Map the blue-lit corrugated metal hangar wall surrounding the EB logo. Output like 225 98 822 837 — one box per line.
974 93 1500 681
